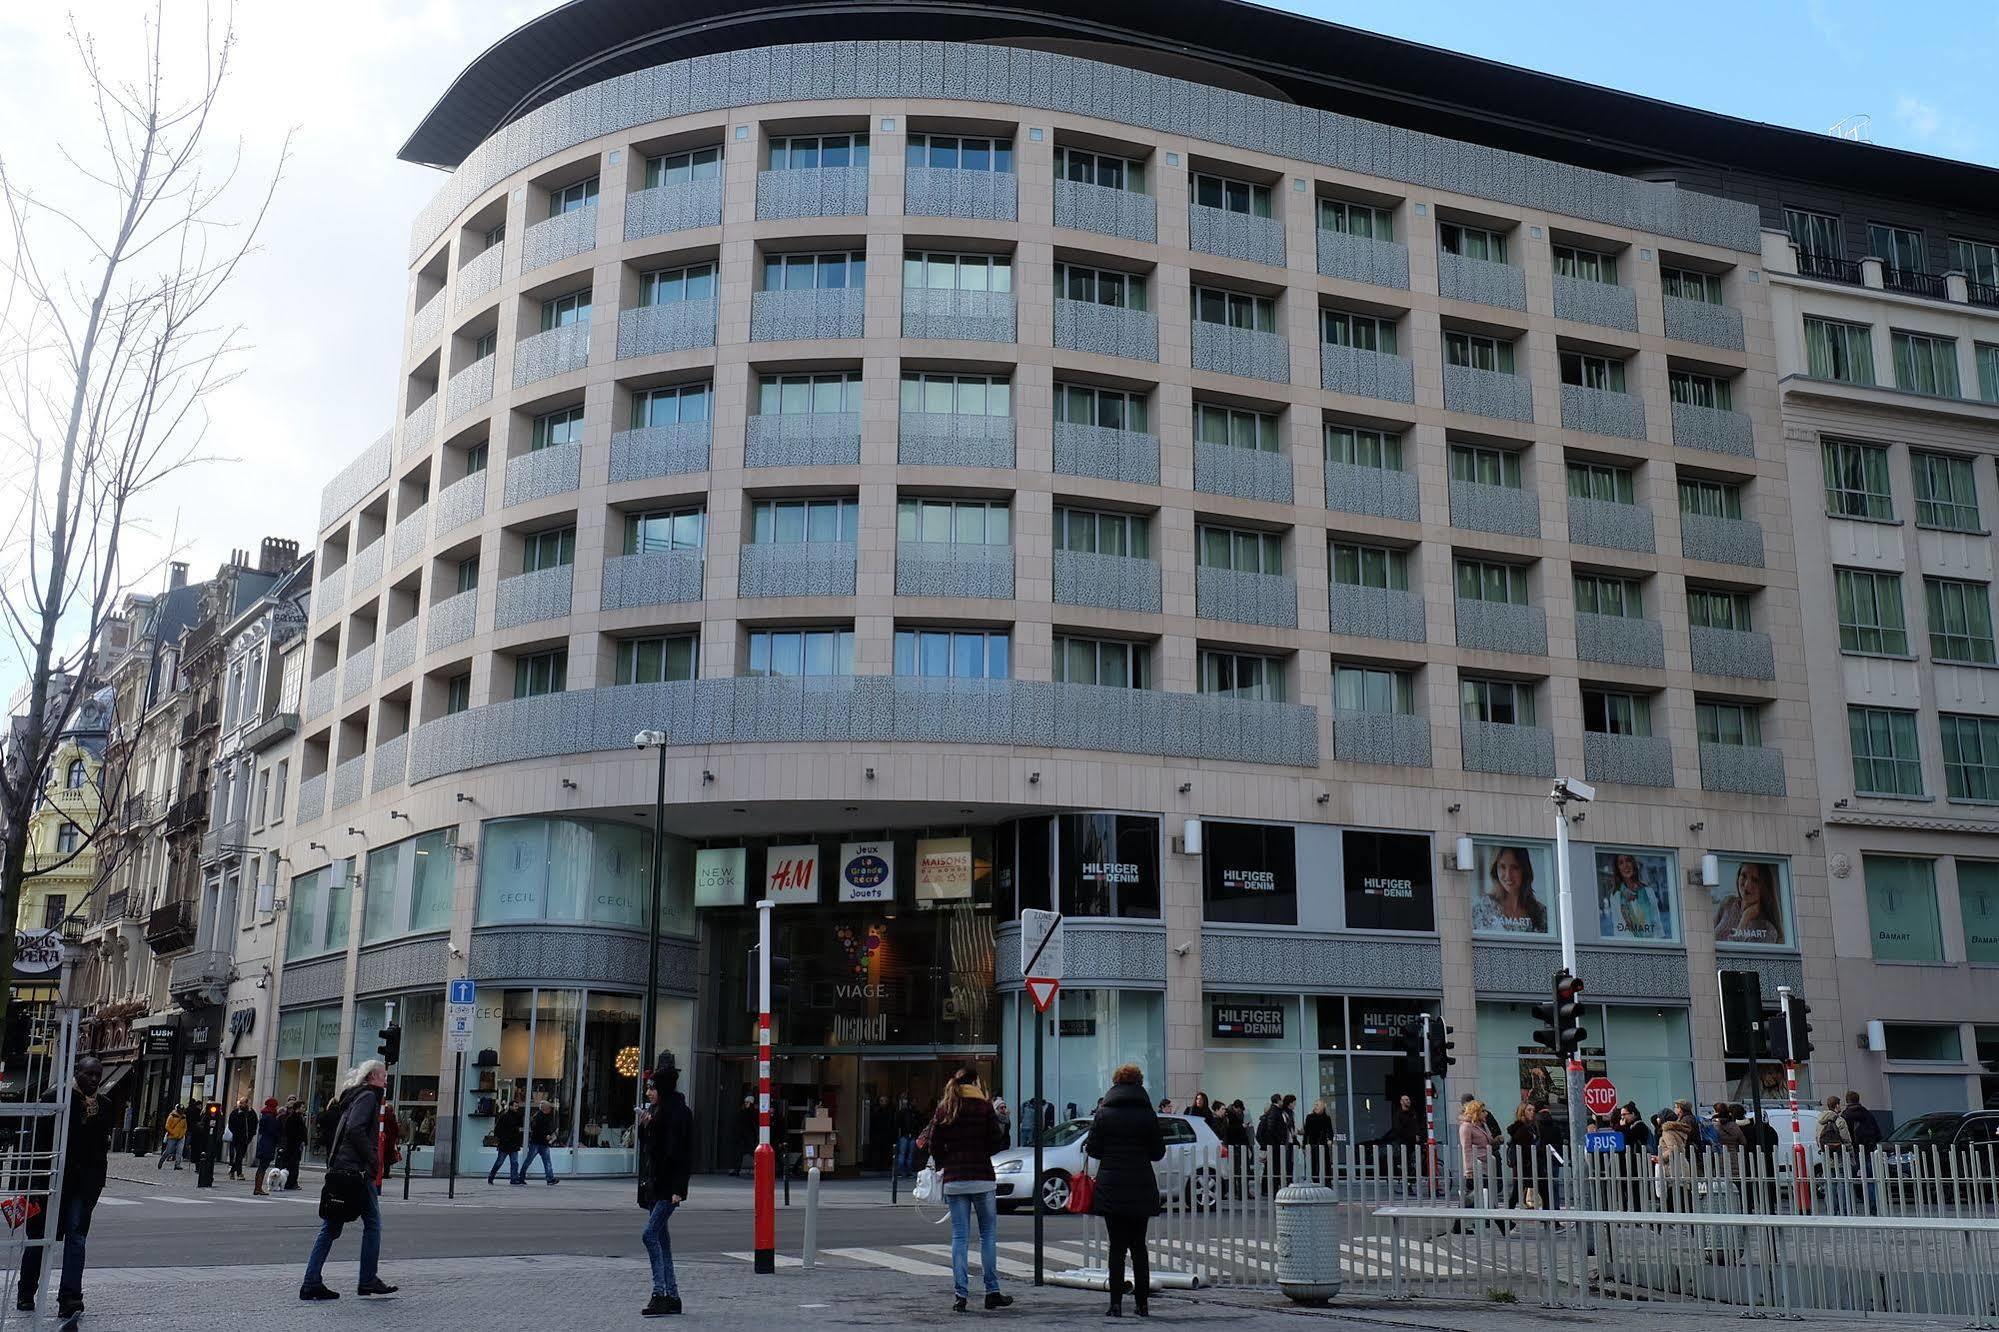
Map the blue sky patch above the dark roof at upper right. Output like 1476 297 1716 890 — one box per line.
1295 0 1999 166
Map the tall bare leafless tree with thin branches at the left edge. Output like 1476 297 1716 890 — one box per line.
0 0 290 1012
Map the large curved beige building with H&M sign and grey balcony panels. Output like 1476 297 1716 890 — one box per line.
266 0 1871 1170
